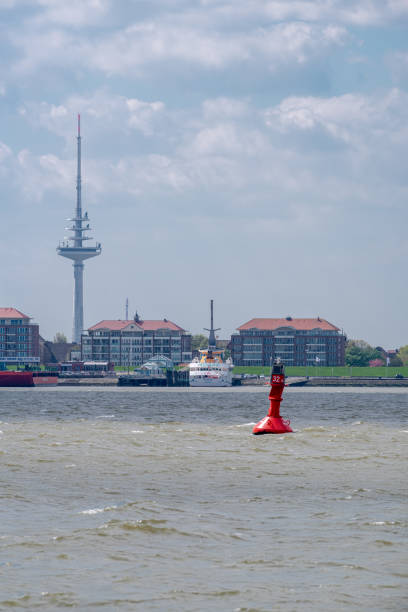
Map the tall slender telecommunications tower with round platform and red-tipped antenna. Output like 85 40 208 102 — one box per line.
57 115 102 343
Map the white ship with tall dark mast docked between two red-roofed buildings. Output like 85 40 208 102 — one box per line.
189 300 233 387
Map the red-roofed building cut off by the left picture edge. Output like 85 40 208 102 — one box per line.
0 308 40 365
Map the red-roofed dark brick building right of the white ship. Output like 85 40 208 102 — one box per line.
230 317 346 366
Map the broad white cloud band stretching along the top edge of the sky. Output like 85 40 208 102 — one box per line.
3 0 408 86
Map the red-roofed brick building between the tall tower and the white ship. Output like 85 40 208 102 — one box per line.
81 317 192 367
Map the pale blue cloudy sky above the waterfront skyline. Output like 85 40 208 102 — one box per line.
0 0 408 348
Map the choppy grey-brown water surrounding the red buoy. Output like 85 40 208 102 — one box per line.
0 387 408 612
